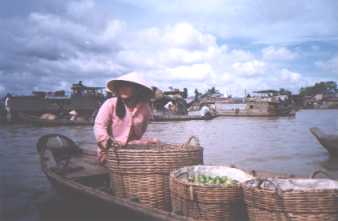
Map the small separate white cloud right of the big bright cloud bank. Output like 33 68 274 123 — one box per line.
262 46 298 61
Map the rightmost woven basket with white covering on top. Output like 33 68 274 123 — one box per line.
242 174 338 221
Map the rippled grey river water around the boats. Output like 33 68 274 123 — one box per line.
0 110 338 221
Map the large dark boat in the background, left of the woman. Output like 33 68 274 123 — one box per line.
8 81 107 122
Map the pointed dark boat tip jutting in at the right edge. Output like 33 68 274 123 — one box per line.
310 127 338 157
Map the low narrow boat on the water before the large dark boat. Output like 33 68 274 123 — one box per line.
18 113 93 126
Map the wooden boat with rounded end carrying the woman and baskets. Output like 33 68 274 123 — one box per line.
37 134 189 221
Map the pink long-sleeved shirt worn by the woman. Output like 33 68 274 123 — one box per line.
94 98 152 151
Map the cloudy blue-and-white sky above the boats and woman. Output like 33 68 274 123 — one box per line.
0 0 338 96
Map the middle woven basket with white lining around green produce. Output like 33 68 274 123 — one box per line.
170 166 253 221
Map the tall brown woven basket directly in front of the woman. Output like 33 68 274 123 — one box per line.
108 137 203 211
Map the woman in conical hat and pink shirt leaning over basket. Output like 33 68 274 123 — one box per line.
94 73 158 163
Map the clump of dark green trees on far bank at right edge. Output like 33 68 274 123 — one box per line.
299 81 338 96
